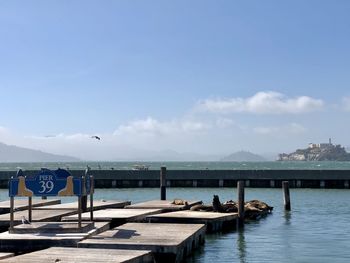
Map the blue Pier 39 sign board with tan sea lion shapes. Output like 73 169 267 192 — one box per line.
9 168 90 197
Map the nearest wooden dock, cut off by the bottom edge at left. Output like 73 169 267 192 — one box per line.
2 247 154 263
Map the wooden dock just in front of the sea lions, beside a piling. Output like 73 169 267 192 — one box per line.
146 210 238 232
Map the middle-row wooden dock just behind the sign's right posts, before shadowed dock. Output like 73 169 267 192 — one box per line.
62 208 161 228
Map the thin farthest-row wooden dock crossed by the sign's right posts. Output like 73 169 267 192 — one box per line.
34 200 130 211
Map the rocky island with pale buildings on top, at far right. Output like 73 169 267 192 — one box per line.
277 139 350 161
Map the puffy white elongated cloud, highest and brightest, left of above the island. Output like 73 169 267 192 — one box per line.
196 91 324 114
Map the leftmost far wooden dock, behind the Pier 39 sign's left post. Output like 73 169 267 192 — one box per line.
0 198 61 214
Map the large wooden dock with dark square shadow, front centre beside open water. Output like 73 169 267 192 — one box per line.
78 223 205 262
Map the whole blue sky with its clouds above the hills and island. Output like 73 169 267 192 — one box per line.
0 0 350 160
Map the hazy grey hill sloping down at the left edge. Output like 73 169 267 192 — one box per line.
0 143 80 162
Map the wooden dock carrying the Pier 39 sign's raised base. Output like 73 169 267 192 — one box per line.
0 222 109 252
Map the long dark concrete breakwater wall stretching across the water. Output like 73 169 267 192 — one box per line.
0 170 350 189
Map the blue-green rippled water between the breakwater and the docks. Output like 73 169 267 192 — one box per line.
0 188 350 263
